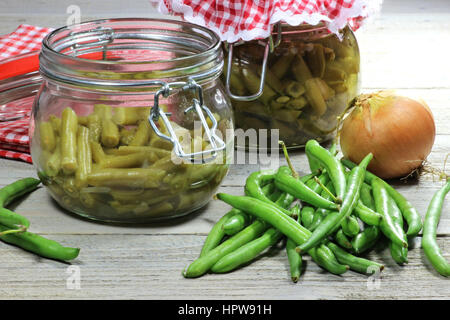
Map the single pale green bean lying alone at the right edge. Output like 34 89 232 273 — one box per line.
422 181 450 277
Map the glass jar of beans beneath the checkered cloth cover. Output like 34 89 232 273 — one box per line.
224 25 360 149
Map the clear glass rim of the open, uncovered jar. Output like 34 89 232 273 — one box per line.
40 18 223 87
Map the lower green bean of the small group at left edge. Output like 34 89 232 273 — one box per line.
0 225 80 261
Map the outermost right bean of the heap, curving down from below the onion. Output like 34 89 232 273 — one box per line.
341 159 423 237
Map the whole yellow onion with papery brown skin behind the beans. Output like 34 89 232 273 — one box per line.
340 90 436 179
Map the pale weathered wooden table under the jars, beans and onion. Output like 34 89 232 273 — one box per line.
0 0 450 299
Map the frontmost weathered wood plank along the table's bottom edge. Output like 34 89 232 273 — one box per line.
0 235 450 299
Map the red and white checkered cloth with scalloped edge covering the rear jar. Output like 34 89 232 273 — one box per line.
150 0 382 43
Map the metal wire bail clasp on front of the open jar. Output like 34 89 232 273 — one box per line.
148 79 226 163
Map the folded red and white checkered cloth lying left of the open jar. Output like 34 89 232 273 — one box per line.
0 25 51 163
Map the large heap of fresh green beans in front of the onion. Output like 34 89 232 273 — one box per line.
183 140 436 282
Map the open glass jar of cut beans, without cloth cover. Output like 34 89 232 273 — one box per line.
30 19 233 223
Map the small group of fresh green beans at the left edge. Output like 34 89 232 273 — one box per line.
0 178 80 261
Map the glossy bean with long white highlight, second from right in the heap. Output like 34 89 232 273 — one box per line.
372 179 408 247
